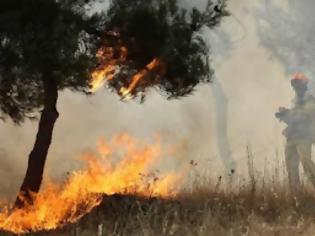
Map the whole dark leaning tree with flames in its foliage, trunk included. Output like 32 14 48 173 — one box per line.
0 0 227 207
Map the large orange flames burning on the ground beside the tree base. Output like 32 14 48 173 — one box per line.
0 134 183 234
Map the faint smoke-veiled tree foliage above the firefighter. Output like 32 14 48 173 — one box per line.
256 0 315 93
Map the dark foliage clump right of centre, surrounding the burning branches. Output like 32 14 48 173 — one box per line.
105 0 228 98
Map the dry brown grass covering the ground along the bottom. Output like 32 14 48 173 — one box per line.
0 186 315 236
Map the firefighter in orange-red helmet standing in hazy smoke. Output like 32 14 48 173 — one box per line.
276 74 315 192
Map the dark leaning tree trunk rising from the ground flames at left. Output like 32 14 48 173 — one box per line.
15 78 59 208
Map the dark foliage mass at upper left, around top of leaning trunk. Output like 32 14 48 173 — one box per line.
0 0 100 123
